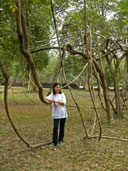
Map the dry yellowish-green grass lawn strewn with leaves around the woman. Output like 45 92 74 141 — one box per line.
0 88 128 171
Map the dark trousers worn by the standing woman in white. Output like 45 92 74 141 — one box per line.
52 118 66 145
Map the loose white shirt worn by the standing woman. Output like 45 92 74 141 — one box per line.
46 93 68 119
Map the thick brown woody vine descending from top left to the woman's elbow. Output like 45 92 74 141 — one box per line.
15 0 47 103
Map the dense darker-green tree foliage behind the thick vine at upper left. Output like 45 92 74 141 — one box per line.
0 0 50 83
